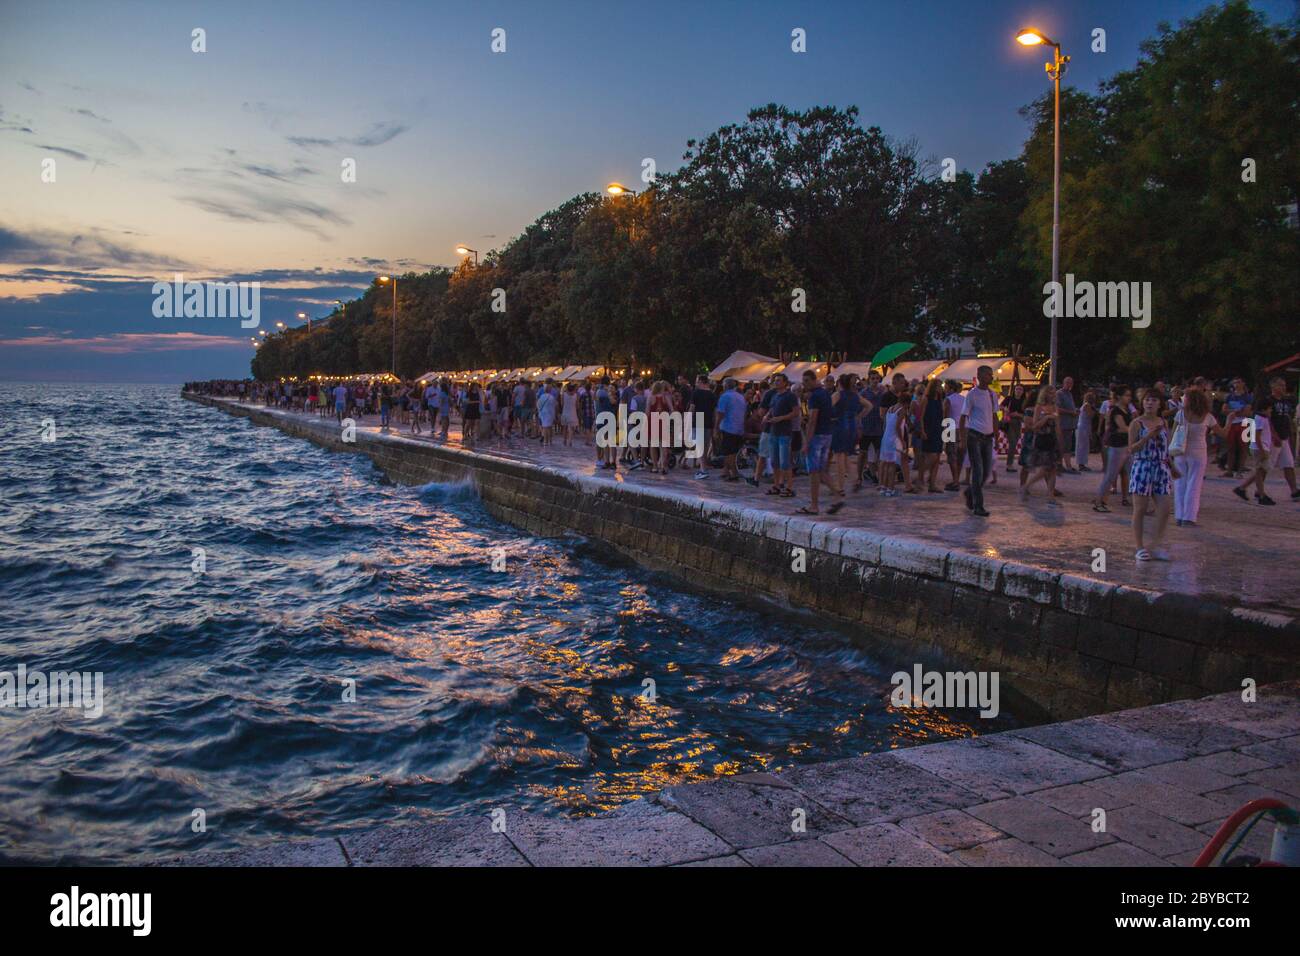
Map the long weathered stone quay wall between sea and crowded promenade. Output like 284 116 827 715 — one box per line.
186 394 1300 721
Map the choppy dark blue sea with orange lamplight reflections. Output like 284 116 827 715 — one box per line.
0 385 1011 860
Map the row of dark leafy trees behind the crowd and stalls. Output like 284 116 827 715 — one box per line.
254 1 1300 377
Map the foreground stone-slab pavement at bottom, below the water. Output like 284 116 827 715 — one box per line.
180 682 1300 866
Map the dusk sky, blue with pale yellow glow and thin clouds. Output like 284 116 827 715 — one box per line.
0 0 1295 381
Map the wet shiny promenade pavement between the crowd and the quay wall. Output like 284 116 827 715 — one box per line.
228 406 1300 615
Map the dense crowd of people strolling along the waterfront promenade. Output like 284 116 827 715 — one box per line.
187 365 1300 561
